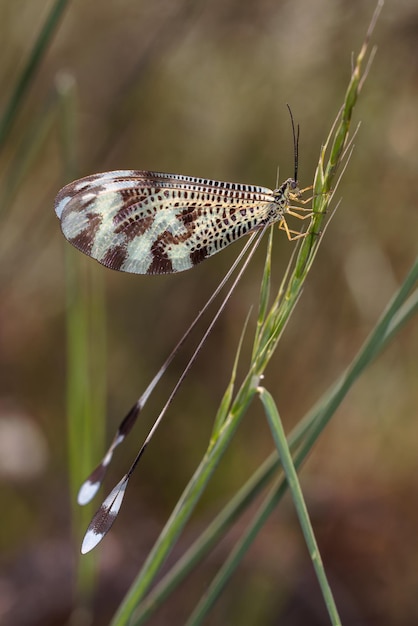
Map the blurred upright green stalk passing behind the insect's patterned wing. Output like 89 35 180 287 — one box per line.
56 68 106 604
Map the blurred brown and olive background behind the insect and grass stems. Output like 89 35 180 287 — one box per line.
0 0 418 626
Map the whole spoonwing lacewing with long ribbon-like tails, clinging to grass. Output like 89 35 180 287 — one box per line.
55 109 312 553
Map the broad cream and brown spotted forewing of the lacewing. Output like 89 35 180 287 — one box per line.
55 170 282 274
